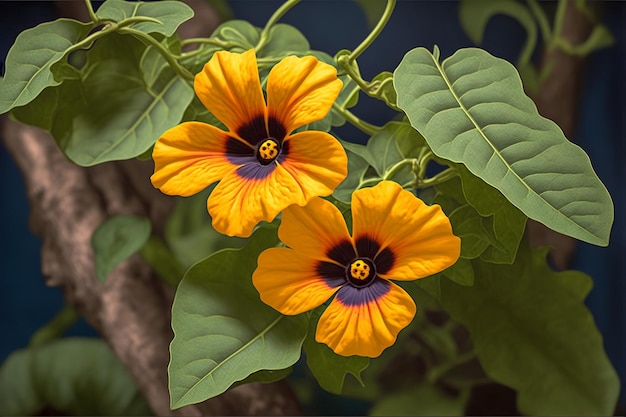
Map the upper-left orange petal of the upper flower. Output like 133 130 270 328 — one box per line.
193 49 266 139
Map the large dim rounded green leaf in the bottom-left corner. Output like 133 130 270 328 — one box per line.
0 338 152 416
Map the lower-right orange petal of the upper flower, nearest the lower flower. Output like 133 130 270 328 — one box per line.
282 131 348 200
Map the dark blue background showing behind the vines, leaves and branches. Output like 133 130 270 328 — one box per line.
0 0 626 413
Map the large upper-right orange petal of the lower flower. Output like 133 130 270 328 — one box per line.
352 181 461 280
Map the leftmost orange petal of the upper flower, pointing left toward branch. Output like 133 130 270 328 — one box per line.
150 122 237 196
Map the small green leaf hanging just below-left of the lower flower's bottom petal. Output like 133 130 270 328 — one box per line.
304 309 370 395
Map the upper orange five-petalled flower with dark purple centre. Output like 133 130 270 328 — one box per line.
151 50 348 237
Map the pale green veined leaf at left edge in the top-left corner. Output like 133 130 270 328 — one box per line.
0 19 93 114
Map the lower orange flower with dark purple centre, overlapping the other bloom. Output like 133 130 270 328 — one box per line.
252 181 461 357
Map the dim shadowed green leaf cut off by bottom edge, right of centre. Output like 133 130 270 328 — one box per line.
369 384 469 416
